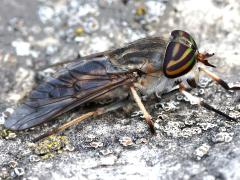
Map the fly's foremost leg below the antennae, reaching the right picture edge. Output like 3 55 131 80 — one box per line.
199 67 240 90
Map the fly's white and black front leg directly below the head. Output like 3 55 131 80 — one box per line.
179 84 237 122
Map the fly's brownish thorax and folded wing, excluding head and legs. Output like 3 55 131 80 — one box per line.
5 37 168 130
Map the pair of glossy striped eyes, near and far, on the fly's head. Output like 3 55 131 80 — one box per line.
163 30 197 78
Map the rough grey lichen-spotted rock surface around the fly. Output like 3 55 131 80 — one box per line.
0 0 240 180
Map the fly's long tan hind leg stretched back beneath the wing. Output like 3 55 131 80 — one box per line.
32 100 129 143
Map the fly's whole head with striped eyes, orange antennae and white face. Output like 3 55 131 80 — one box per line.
163 30 215 86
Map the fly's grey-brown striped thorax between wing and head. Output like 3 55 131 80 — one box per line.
108 37 167 72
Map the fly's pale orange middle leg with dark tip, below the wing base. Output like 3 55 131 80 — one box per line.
130 86 155 134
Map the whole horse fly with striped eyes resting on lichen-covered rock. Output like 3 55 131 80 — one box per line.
4 30 240 141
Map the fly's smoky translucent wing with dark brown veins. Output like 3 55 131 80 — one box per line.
4 57 131 130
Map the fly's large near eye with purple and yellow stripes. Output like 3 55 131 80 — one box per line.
163 42 196 78
